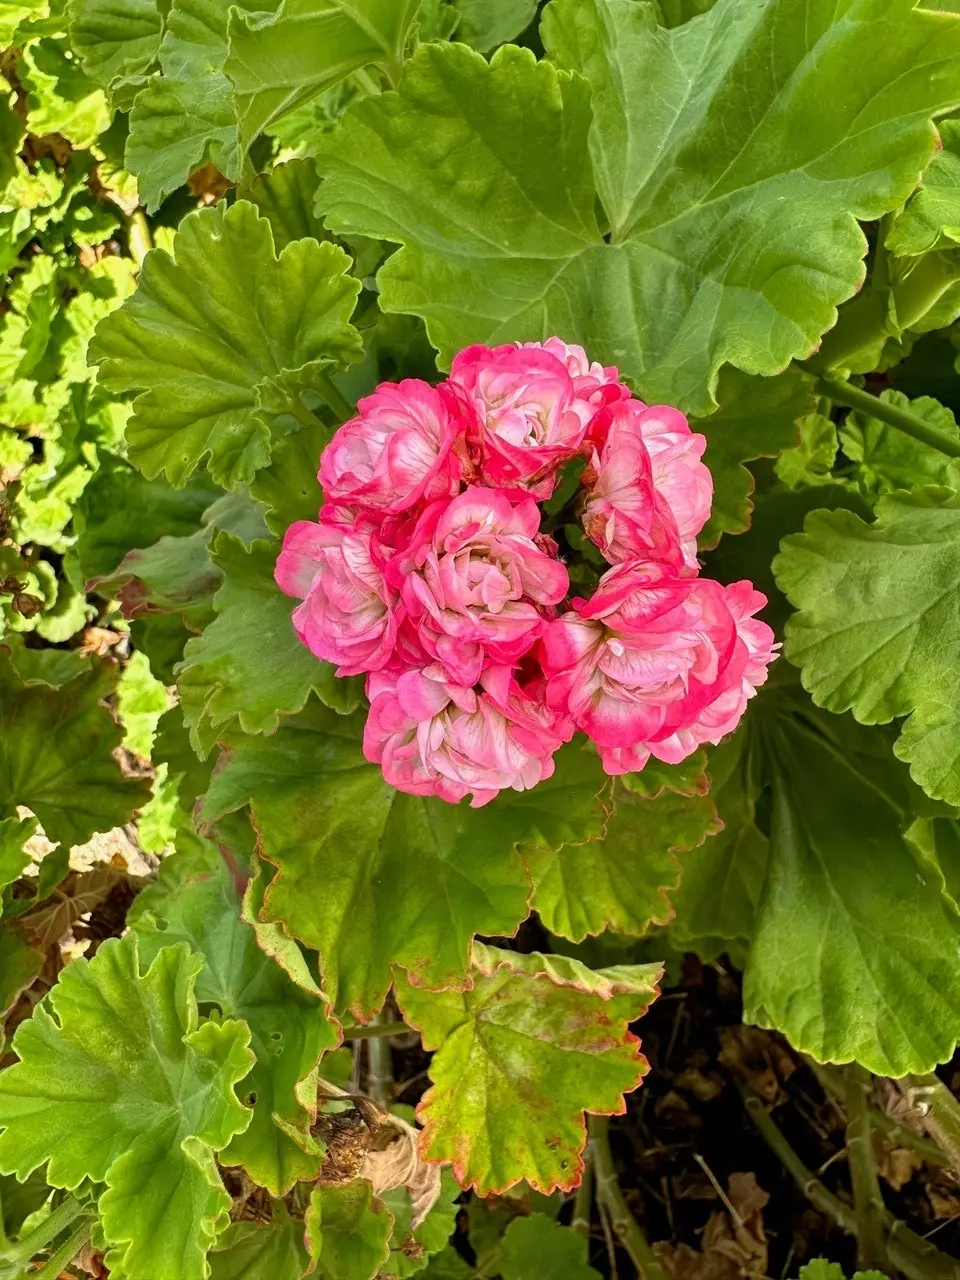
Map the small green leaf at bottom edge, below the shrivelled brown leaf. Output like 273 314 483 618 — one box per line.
307 1178 393 1280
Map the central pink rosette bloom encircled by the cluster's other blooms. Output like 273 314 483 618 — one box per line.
387 488 568 686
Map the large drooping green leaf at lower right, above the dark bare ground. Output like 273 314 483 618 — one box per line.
744 669 960 1076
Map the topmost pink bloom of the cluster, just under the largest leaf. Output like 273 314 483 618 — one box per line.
451 346 595 499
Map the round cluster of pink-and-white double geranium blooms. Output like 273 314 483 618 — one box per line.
276 338 776 805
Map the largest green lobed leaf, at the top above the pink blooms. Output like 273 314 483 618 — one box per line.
317 0 960 413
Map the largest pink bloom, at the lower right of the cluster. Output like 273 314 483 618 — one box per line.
541 561 777 773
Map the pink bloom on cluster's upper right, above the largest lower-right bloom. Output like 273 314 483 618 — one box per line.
582 401 713 573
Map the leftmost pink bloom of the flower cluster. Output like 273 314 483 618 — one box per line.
275 508 397 676
